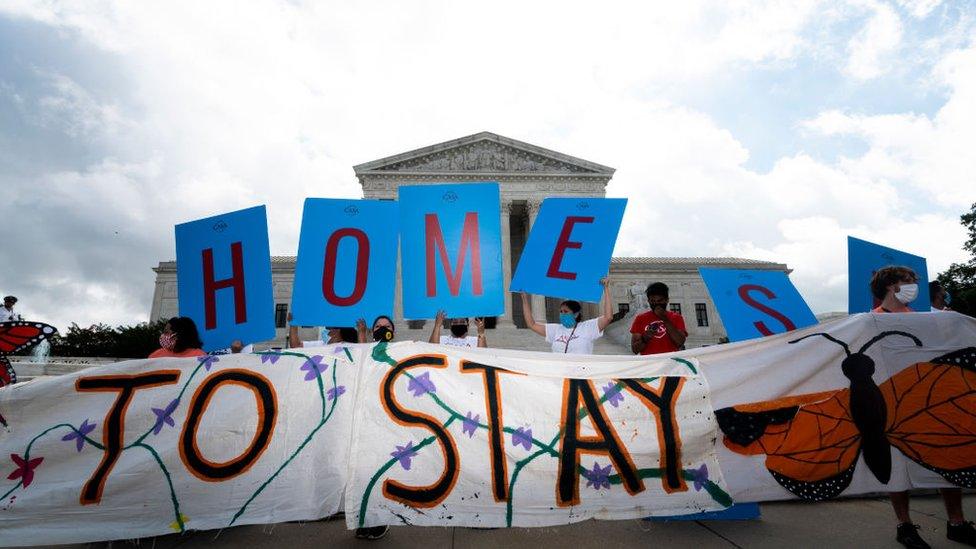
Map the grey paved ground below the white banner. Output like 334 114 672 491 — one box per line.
15 494 976 549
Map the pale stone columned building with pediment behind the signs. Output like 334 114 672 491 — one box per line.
150 132 789 354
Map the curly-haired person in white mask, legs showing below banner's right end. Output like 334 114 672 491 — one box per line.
871 266 976 548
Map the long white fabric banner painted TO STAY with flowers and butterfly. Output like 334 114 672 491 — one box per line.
0 313 976 546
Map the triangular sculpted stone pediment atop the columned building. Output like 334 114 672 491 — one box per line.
353 132 614 178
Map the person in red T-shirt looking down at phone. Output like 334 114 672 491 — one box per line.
630 282 688 355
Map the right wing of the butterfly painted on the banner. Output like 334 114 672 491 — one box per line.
880 347 976 488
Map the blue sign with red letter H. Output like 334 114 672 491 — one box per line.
176 206 275 351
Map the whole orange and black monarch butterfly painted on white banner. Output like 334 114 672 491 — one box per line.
716 331 976 501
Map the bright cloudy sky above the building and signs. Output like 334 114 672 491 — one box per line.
0 0 976 330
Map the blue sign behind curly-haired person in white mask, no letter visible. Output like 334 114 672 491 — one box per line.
847 236 932 314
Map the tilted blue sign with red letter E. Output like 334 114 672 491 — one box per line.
511 198 627 302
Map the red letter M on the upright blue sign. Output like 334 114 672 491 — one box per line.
425 212 482 297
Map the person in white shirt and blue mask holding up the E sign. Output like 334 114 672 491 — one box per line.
522 277 613 355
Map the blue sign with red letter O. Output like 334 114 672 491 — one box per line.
291 198 399 327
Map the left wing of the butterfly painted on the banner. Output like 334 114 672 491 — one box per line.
715 389 861 501
